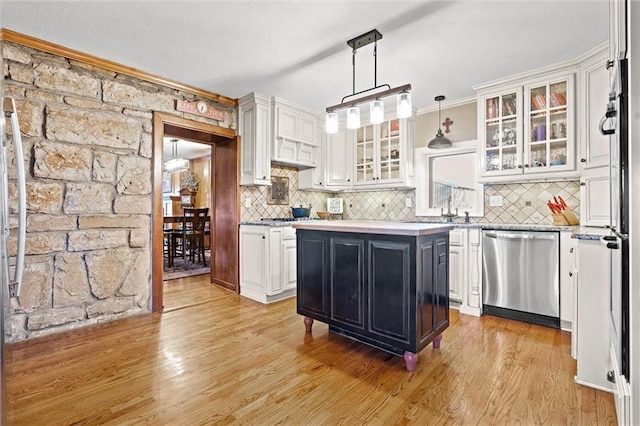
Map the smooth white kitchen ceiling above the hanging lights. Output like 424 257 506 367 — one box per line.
0 0 608 116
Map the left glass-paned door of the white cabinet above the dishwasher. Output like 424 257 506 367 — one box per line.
482 89 522 176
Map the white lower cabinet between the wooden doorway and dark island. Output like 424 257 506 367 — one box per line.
240 225 296 303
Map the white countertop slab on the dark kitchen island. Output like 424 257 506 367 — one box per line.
292 220 454 235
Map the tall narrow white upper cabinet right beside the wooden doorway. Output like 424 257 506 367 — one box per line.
238 93 271 185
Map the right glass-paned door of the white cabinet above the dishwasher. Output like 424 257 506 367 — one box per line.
524 78 574 173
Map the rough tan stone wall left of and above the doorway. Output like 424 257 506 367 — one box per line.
2 42 236 341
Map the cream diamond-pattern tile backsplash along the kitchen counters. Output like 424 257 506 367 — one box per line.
241 165 580 225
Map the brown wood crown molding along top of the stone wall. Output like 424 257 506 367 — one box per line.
0 28 238 108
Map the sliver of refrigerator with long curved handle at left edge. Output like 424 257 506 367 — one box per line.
0 96 26 426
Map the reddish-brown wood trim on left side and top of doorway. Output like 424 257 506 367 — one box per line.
151 112 239 312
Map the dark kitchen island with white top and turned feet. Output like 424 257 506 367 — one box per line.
293 220 453 371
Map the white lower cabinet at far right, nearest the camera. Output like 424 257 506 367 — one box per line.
574 240 611 391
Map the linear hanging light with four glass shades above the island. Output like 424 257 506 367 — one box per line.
325 30 413 133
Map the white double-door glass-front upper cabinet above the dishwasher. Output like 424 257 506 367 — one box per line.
476 66 579 182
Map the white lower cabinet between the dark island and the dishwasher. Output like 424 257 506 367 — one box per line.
449 228 482 316
